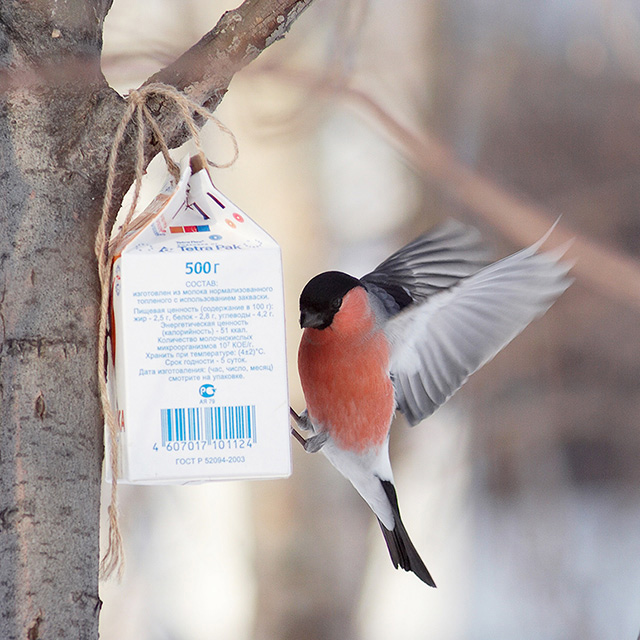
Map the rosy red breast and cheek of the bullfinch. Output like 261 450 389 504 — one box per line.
298 287 395 453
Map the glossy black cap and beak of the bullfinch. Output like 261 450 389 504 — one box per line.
300 271 362 329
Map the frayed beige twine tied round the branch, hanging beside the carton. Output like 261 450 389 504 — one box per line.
95 83 238 579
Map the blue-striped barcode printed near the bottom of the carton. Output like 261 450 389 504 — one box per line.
160 404 257 446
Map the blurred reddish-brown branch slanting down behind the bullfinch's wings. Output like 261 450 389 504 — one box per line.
255 66 640 311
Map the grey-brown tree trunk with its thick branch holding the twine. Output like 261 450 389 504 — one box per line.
0 0 311 640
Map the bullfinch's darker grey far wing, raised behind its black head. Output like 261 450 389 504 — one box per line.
360 220 489 315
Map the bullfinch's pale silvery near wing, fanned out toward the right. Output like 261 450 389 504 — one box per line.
383 239 571 425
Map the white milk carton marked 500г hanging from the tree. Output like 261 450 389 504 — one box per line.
107 162 291 484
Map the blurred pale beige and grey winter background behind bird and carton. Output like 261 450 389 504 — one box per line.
101 0 640 640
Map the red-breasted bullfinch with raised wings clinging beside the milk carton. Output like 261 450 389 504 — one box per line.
292 221 571 587
